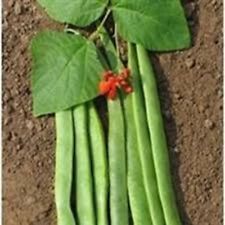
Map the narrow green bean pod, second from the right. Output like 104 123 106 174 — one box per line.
128 43 165 225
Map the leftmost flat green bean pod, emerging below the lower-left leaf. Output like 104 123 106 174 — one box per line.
55 110 76 225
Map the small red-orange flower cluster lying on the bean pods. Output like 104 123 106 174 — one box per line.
99 68 133 100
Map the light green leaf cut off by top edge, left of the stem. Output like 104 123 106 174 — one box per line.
38 0 108 27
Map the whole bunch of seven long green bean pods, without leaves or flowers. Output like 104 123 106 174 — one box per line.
55 27 184 225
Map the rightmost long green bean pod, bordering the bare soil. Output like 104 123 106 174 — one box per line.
137 45 181 225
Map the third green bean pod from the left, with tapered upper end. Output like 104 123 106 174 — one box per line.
88 102 109 225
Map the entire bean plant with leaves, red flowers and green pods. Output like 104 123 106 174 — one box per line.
31 0 191 225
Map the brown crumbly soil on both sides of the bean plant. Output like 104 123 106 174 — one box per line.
3 0 223 225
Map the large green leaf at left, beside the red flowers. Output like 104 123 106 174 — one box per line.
31 32 103 116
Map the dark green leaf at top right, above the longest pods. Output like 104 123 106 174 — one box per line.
111 0 190 51
